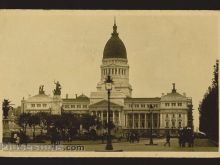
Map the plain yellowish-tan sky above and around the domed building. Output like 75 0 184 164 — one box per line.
0 10 220 130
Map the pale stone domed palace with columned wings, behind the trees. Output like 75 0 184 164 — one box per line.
21 20 192 135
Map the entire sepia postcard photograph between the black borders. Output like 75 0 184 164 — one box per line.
0 10 220 157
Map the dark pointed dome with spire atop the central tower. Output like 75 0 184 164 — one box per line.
103 20 127 59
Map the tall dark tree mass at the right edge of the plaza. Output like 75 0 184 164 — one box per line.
199 60 219 142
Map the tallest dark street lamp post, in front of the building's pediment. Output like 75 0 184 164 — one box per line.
105 75 113 150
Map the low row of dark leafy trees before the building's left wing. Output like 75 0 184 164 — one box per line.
17 112 115 138
